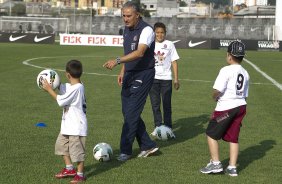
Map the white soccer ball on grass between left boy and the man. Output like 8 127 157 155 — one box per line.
93 142 113 162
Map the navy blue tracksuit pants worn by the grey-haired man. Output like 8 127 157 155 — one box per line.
120 68 156 155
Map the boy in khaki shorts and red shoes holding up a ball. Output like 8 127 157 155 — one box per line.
43 60 87 183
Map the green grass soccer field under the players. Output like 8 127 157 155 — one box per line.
0 43 282 184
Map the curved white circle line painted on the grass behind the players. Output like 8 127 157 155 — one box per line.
22 56 276 86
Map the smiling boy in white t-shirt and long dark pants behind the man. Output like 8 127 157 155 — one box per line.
149 22 179 138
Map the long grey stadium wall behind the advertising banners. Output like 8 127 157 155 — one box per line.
0 15 276 40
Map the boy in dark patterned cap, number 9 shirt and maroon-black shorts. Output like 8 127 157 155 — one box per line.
200 41 250 176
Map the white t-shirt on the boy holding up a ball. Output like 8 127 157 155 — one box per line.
57 83 87 136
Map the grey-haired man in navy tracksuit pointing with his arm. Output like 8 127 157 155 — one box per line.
103 1 159 161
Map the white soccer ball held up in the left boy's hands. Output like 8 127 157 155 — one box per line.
36 69 60 89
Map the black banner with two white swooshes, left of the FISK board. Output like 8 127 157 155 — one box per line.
0 33 55 44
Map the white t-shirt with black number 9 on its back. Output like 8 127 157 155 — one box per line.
213 64 250 111
